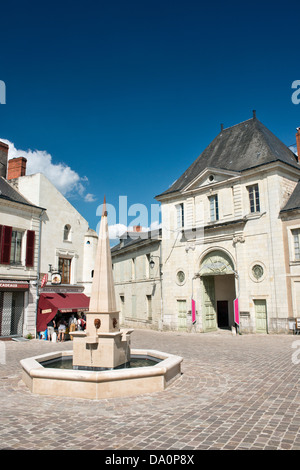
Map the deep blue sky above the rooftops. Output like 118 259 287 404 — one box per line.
0 0 300 239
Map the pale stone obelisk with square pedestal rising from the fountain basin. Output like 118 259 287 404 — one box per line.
72 198 133 370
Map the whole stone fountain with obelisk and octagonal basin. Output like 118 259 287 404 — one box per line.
21 198 182 399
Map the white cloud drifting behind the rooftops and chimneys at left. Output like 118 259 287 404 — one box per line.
0 139 96 202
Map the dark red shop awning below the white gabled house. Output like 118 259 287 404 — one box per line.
36 292 90 332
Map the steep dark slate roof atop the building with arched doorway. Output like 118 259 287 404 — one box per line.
156 117 300 198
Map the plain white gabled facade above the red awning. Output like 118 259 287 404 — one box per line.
10 173 98 296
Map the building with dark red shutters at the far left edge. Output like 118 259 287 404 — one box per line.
0 142 45 337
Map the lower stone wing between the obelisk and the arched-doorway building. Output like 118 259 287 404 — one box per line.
111 227 163 328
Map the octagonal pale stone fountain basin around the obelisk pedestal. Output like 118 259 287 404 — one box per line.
21 349 183 399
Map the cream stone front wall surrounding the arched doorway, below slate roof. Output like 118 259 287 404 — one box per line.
158 170 300 332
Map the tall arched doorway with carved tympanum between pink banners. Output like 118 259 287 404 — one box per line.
199 250 236 331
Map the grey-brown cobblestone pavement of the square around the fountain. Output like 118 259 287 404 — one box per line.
0 330 300 451
